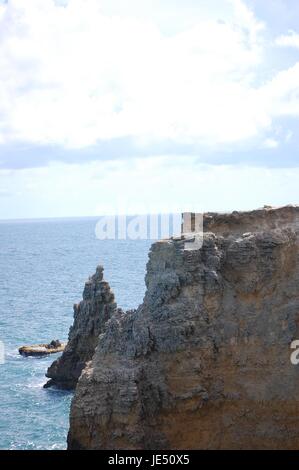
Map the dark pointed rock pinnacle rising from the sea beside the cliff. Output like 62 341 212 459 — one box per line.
44 266 117 389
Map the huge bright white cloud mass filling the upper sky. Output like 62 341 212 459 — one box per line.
0 0 299 152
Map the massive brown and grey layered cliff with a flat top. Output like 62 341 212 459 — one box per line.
62 206 299 449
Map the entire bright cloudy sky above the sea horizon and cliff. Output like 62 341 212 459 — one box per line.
0 0 299 219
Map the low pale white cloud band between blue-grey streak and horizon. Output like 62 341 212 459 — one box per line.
0 156 299 219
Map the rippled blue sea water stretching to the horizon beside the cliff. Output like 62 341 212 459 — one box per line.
0 219 151 449
